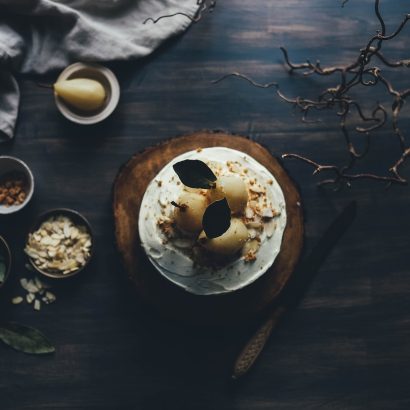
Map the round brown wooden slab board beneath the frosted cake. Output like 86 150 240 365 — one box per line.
113 131 303 324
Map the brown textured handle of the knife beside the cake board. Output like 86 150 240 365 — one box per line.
232 306 285 379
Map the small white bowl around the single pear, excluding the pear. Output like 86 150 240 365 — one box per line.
54 63 120 125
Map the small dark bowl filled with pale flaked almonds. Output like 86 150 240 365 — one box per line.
24 208 94 279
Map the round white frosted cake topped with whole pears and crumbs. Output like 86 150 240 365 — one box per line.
138 147 286 295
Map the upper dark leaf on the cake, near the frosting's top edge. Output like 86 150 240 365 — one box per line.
172 159 216 189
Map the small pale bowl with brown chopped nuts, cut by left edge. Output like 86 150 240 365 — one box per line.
0 156 34 215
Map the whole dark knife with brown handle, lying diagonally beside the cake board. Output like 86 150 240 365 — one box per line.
232 201 357 379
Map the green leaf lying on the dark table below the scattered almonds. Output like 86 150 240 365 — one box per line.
0 322 55 354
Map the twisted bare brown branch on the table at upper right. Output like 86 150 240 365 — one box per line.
214 0 410 187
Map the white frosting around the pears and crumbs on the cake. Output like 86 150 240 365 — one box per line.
139 147 286 295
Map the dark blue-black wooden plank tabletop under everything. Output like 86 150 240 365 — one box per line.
0 0 410 410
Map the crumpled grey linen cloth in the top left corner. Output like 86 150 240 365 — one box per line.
0 0 199 139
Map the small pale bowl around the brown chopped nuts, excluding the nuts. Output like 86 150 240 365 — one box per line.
0 156 34 215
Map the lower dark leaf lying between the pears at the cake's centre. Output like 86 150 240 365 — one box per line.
202 198 231 239
